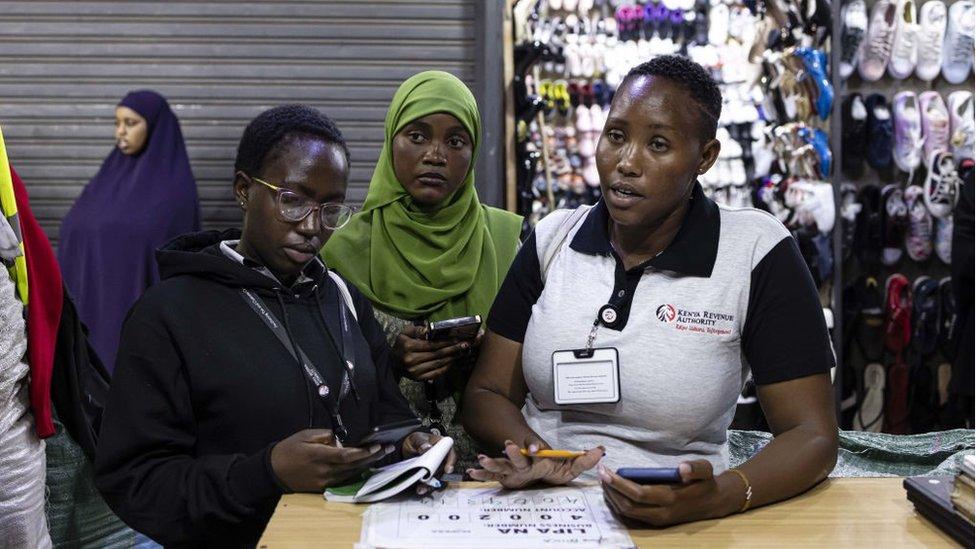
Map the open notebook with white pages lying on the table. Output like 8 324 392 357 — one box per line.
323 437 454 503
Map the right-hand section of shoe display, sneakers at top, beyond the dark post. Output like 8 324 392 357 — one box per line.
833 0 976 433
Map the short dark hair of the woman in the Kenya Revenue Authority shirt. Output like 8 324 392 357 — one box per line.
621 55 722 141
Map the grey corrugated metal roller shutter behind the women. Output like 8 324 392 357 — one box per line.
0 0 477 248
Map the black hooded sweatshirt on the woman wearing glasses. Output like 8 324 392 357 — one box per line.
95 231 413 547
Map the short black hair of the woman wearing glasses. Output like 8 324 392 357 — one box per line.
234 105 349 175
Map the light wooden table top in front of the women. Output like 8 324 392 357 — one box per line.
258 478 955 549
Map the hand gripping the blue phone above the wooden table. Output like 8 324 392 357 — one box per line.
599 459 745 526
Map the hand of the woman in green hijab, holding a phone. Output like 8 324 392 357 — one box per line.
393 324 481 381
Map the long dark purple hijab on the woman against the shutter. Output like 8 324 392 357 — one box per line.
58 90 200 370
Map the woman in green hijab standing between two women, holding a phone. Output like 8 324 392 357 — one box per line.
322 71 522 463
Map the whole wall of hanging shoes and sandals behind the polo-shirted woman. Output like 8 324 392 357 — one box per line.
514 0 976 432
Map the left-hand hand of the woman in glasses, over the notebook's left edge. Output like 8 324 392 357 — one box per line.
271 429 395 492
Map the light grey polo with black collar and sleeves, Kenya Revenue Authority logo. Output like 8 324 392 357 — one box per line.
488 185 834 473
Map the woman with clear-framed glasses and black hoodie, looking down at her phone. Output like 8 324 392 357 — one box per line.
95 105 453 547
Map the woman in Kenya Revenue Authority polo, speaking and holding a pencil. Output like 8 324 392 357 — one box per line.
463 56 837 525
